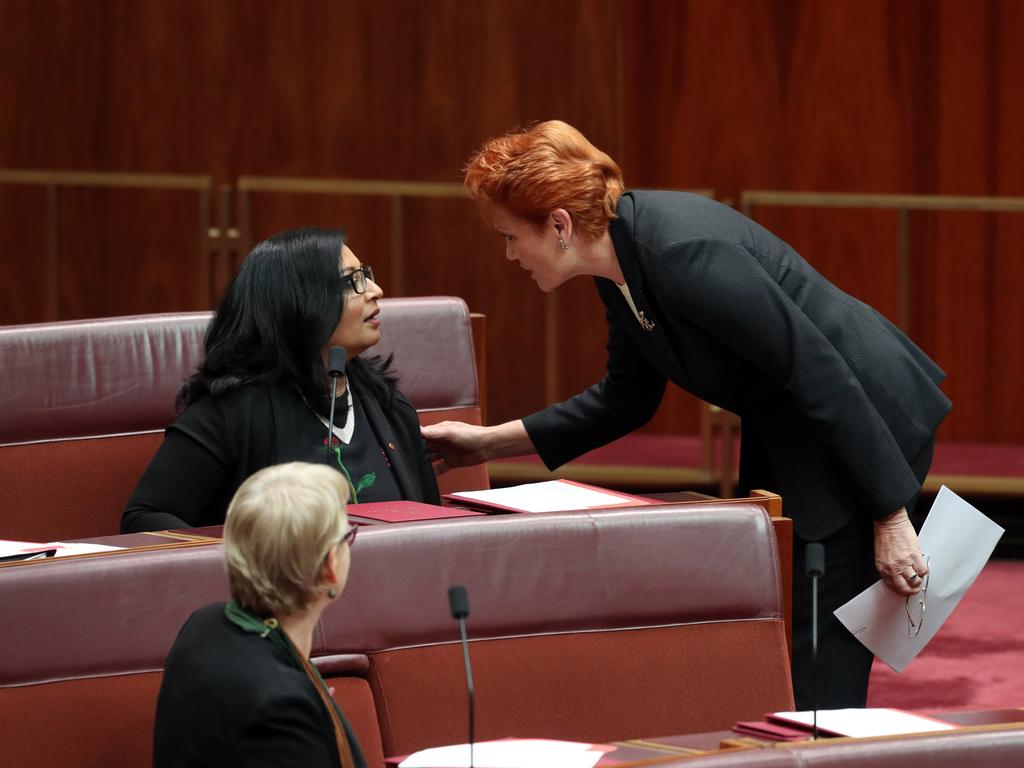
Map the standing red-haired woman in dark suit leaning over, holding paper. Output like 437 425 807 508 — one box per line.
423 121 950 709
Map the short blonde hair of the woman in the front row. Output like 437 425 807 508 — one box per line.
224 462 348 618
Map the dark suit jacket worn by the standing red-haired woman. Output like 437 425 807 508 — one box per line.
524 191 950 540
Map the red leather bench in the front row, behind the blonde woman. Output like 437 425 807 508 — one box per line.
0 503 793 766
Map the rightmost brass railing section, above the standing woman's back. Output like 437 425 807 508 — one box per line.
739 189 1024 330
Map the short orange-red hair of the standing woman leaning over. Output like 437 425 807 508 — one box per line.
465 120 625 240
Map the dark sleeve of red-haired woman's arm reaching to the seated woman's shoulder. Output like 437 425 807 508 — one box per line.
522 299 666 469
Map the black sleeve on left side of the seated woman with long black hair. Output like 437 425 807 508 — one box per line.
121 397 237 534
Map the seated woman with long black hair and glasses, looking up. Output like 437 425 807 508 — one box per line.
121 228 438 532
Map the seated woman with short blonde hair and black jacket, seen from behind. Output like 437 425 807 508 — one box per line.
154 462 365 768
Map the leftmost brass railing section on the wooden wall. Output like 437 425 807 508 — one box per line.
0 169 214 319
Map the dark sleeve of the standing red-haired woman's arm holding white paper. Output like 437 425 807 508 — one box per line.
663 241 920 517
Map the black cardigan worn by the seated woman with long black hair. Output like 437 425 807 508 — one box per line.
121 385 440 534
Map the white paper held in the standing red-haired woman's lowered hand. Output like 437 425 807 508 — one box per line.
836 485 1004 672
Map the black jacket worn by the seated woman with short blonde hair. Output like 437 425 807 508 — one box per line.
153 603 364 768
